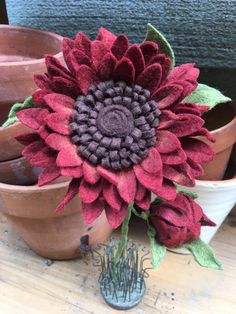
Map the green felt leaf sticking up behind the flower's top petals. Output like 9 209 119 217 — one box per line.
145 23 175 68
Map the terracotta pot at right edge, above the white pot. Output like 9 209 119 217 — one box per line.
199 103 236 180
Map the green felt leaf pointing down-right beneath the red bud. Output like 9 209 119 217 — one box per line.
183 239 223 270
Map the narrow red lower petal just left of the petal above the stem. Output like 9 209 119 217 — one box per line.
103 181 123 212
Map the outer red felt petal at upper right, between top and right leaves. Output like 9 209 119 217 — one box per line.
168 63 199 82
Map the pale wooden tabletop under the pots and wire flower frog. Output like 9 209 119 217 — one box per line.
0 214 236 314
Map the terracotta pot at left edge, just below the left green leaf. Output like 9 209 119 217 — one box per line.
0 122 31 161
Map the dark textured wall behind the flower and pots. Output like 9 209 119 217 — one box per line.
0 0 236 100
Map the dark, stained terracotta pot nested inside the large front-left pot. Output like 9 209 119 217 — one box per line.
0 157 41 185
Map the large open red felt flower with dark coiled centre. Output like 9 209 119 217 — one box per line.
17 28 213 227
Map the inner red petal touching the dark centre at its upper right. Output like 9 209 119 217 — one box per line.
152 84 183 109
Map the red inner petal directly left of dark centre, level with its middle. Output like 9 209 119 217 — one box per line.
45 112 71 135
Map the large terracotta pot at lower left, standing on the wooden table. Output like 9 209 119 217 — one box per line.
0 181 112 260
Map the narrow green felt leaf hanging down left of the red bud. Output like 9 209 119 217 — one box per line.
148 226 166 269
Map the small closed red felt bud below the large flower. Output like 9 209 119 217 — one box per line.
150 193 215 248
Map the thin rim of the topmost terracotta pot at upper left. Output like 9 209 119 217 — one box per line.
0 25 63 67
